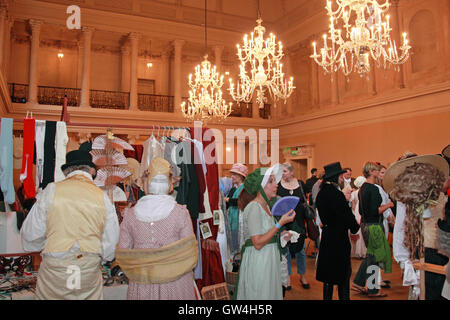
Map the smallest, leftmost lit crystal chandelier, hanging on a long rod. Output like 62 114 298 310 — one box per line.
181 0 232 122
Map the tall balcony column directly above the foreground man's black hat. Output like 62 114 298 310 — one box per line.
80 27 94 108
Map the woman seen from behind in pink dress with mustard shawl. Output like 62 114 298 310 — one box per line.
116 158 198 300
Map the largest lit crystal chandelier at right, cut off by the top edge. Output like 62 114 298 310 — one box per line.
310 0 411 77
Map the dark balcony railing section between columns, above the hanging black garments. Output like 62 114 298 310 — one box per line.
38 86 81 107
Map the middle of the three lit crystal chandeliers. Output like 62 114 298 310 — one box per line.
228 0 295 109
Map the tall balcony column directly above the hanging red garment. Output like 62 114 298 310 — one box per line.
28 19 43 104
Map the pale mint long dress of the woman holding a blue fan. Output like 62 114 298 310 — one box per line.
237 201 283 300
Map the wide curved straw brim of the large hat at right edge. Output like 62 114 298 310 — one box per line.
383 154 449 193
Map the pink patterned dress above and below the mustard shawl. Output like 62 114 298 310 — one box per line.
117 204 195 300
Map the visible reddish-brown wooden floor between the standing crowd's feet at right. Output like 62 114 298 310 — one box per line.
284 240 409 300
